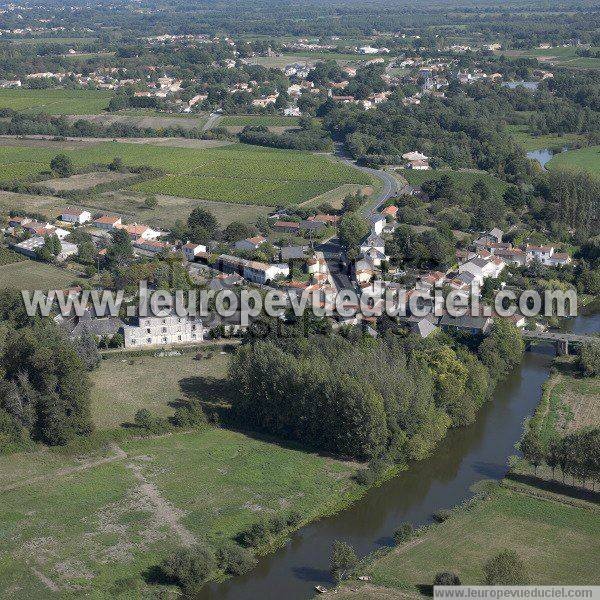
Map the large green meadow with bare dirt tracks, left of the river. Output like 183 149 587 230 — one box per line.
0 424 357 600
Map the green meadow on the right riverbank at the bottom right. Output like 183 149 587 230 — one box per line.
342 484 600 598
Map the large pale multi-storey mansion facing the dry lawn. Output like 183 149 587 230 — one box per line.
123 314 204 348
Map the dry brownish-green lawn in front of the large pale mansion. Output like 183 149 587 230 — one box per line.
92 350 229 429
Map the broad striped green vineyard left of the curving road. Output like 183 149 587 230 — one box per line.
0 142 370 206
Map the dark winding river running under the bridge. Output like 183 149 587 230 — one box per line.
198 312 600 600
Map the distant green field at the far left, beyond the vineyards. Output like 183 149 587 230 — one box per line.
0 89 112 115
